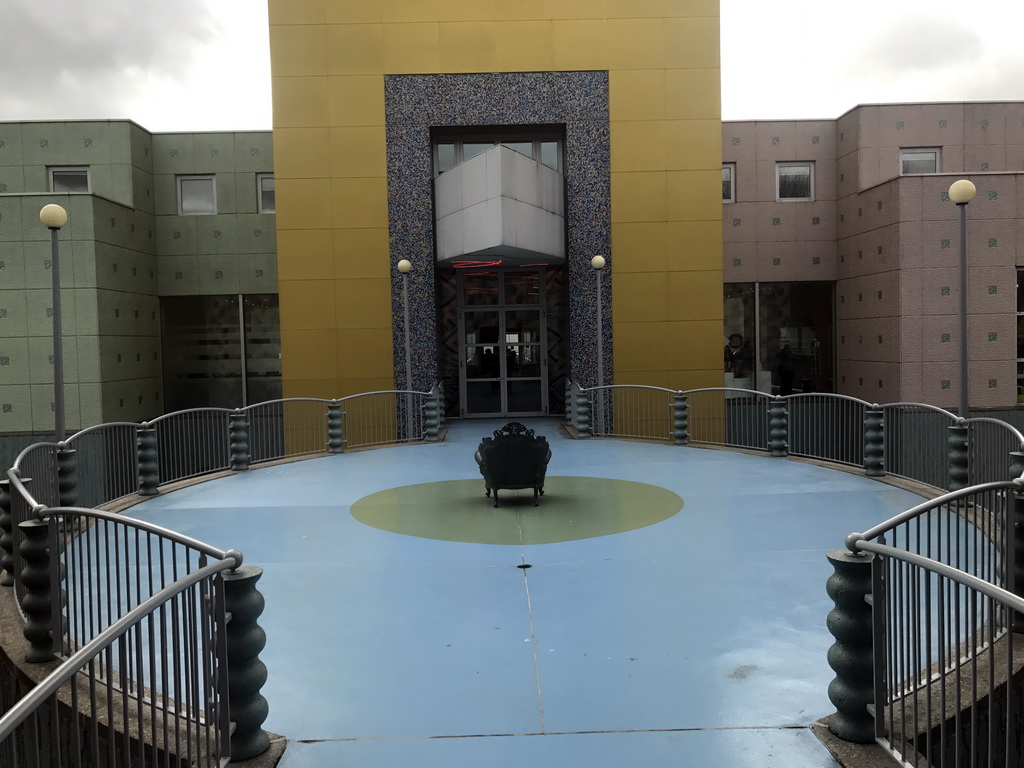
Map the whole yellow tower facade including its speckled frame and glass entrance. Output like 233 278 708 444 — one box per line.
269 0 722 416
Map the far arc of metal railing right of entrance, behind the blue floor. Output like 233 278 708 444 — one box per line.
566 382 1024 489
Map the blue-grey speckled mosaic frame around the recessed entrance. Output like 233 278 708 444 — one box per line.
384 71 611 397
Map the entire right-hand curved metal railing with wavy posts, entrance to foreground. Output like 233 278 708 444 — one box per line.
566 383 1024 768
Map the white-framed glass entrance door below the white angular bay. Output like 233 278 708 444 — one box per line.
459 269 548 416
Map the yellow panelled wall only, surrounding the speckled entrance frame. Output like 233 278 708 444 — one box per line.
270 0 722 396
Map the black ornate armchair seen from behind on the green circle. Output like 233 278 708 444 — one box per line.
474 421 551 507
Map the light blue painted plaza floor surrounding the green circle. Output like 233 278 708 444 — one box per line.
130 420 920 768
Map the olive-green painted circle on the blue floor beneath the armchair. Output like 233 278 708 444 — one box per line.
351 477 683 545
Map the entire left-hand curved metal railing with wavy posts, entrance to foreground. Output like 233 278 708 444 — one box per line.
0 387 442 768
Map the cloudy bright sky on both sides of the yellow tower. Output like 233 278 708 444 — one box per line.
0 0 1024 132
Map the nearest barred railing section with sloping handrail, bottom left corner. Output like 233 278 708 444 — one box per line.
0 558 236 768
